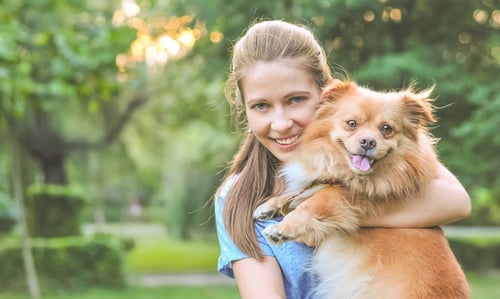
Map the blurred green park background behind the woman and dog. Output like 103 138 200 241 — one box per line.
0 0 500 299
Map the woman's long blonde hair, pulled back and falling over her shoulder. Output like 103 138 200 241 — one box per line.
218 20 331 258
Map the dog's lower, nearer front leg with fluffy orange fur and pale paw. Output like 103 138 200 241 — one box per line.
263 186 359 246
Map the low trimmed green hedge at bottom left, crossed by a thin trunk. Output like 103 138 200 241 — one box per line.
0 237 125 291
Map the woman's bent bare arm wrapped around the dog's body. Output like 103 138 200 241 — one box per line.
362 164 471 227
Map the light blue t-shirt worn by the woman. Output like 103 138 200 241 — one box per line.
215 177 314 299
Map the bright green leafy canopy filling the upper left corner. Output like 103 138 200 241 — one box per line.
0 1 133 117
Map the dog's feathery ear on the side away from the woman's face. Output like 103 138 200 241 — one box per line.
403 85 437 127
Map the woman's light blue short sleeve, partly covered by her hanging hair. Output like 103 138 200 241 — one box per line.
214 177 273 278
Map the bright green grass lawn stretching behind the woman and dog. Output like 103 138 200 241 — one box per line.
0 226 500 299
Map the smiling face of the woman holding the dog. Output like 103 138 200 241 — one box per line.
241 60 320 162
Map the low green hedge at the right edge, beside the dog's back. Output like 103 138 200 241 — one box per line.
448 237 500 271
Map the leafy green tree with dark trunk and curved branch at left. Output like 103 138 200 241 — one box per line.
0 1 148 184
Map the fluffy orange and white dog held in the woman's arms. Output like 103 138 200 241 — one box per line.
254 81 470 299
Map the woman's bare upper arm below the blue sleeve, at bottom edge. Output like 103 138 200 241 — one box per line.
233 256 286 299
